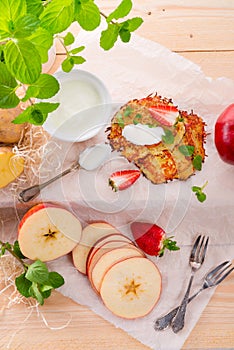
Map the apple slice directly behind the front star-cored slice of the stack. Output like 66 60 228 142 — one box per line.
89 245 144 293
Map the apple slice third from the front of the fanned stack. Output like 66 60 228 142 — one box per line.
86 240 139 278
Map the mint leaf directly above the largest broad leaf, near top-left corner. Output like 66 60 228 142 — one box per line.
11 14 40 38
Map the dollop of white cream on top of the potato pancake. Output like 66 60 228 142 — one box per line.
122 124 165 146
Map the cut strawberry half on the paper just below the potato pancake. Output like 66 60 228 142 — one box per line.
109 170 141 192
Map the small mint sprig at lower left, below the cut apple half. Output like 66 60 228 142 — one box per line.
0 241 64 305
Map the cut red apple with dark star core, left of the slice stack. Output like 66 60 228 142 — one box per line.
18 203 82 261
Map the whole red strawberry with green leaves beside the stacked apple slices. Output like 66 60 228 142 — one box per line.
131 222 180 256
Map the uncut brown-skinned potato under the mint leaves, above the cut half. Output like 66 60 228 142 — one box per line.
0 107 25 143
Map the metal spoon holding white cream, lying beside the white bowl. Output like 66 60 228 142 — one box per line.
18 144 111 203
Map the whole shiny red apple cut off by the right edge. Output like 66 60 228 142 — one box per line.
215 103 234 165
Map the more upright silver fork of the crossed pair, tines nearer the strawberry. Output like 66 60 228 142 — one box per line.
171 235 209 333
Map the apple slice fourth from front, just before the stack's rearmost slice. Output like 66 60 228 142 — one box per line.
86 233 134 273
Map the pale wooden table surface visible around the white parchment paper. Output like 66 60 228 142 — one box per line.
0 0 234 350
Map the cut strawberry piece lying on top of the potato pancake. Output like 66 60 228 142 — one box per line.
149 104 179 126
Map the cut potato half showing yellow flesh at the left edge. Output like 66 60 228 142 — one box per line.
0 147 24 188
